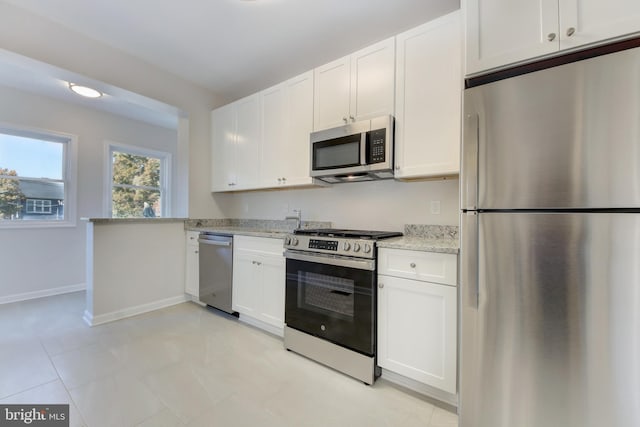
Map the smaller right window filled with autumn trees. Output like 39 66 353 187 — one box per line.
108 145 171 218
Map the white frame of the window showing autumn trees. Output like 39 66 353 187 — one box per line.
104 141 172 219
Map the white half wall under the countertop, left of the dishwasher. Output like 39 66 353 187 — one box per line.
84 221 186 326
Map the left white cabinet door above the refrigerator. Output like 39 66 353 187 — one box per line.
466 0 560 74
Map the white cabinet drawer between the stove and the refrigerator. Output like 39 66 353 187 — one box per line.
378 248 458 286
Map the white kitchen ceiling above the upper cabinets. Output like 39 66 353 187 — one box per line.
3 0 460 100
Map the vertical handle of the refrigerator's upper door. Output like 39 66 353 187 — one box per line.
460 113 480 210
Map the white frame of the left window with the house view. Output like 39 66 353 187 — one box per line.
0 122 78 229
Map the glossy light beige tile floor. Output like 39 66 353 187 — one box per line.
0 292 457 427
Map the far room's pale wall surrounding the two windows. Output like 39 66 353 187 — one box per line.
0 86 177 302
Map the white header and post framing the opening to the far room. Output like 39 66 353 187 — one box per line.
0 2 224 218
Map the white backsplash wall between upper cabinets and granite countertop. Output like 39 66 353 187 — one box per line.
214 179 459 231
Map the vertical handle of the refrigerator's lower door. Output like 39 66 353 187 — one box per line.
460 212 480 308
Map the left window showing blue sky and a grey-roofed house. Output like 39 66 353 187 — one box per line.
0 126 75 227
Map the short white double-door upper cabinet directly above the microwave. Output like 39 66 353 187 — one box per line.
314 38 395 130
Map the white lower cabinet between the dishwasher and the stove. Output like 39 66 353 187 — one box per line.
232 235 285 335
